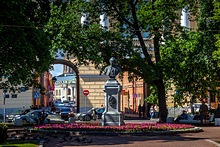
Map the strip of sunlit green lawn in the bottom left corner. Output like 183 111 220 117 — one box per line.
0 140 39 147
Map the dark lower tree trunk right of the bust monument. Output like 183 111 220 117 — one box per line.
154 79 168 123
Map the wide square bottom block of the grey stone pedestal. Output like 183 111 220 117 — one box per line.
102 112 125 126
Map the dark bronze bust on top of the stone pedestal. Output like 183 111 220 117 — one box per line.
104 57 121 79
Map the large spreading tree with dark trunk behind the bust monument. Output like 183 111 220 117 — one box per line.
45 0 216 122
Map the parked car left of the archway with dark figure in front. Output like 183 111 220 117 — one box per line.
14 110 64 124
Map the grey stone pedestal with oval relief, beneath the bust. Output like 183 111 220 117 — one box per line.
102 79 125 126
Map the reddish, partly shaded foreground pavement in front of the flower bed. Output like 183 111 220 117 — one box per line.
40 126 220 147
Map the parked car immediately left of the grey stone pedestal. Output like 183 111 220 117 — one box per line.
75 108 105 121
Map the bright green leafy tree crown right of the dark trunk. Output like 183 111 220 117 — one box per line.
162 0 220 111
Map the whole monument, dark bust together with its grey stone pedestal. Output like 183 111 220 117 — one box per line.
102 57 125 126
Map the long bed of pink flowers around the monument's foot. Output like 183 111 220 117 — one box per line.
34 122 197 133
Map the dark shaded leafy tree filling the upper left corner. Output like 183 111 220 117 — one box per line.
0 0 53 91
